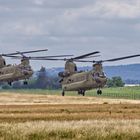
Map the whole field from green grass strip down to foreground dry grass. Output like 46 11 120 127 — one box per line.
0 87 140 140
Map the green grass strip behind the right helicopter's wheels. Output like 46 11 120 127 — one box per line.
0 86 140 100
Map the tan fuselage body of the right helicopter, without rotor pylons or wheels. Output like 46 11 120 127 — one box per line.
61 71 107 91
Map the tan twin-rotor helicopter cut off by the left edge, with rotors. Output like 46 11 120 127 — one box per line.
0 49 72 85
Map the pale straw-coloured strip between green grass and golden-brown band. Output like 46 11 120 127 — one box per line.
0 92 140 105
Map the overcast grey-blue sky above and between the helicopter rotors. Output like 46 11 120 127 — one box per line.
0 0 140 69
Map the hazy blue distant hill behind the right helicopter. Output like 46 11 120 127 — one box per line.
42 64 140 84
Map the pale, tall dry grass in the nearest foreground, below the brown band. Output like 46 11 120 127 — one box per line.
0 120 140 140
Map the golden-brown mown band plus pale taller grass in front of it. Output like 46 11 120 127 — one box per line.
0 103 140 140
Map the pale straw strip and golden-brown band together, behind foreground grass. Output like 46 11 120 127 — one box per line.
0 93 140 122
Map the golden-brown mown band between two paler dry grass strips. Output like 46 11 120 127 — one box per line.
0 104 140 122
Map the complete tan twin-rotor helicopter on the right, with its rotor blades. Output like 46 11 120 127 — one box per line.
33 51 140 96
